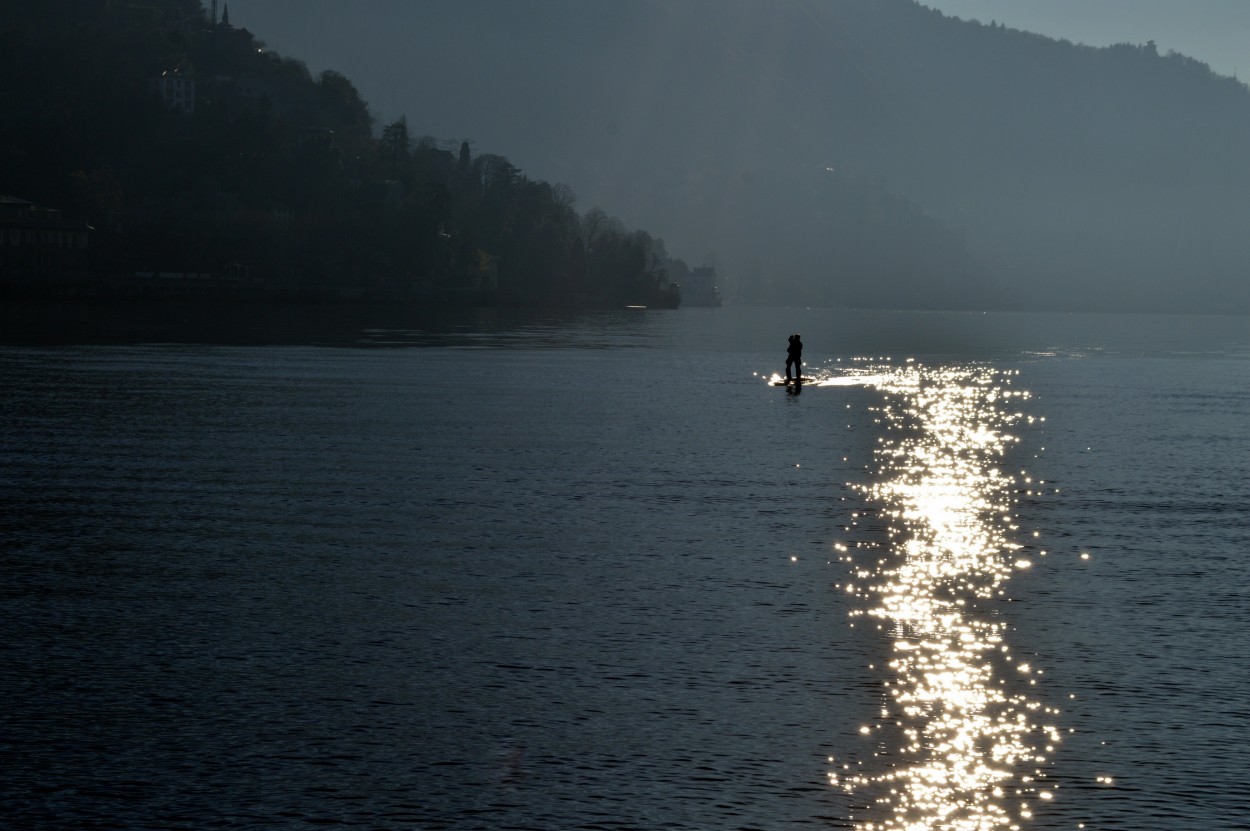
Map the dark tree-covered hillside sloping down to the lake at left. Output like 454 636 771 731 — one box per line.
0 0 683 306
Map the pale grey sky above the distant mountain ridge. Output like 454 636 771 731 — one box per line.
923 0 1250 79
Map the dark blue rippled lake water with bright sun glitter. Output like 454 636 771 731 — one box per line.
0 309 1250 831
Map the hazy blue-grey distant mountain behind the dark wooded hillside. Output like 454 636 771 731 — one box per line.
375 0 1250 311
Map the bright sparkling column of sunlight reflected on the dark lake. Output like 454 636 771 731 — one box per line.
830 364 1060 831
